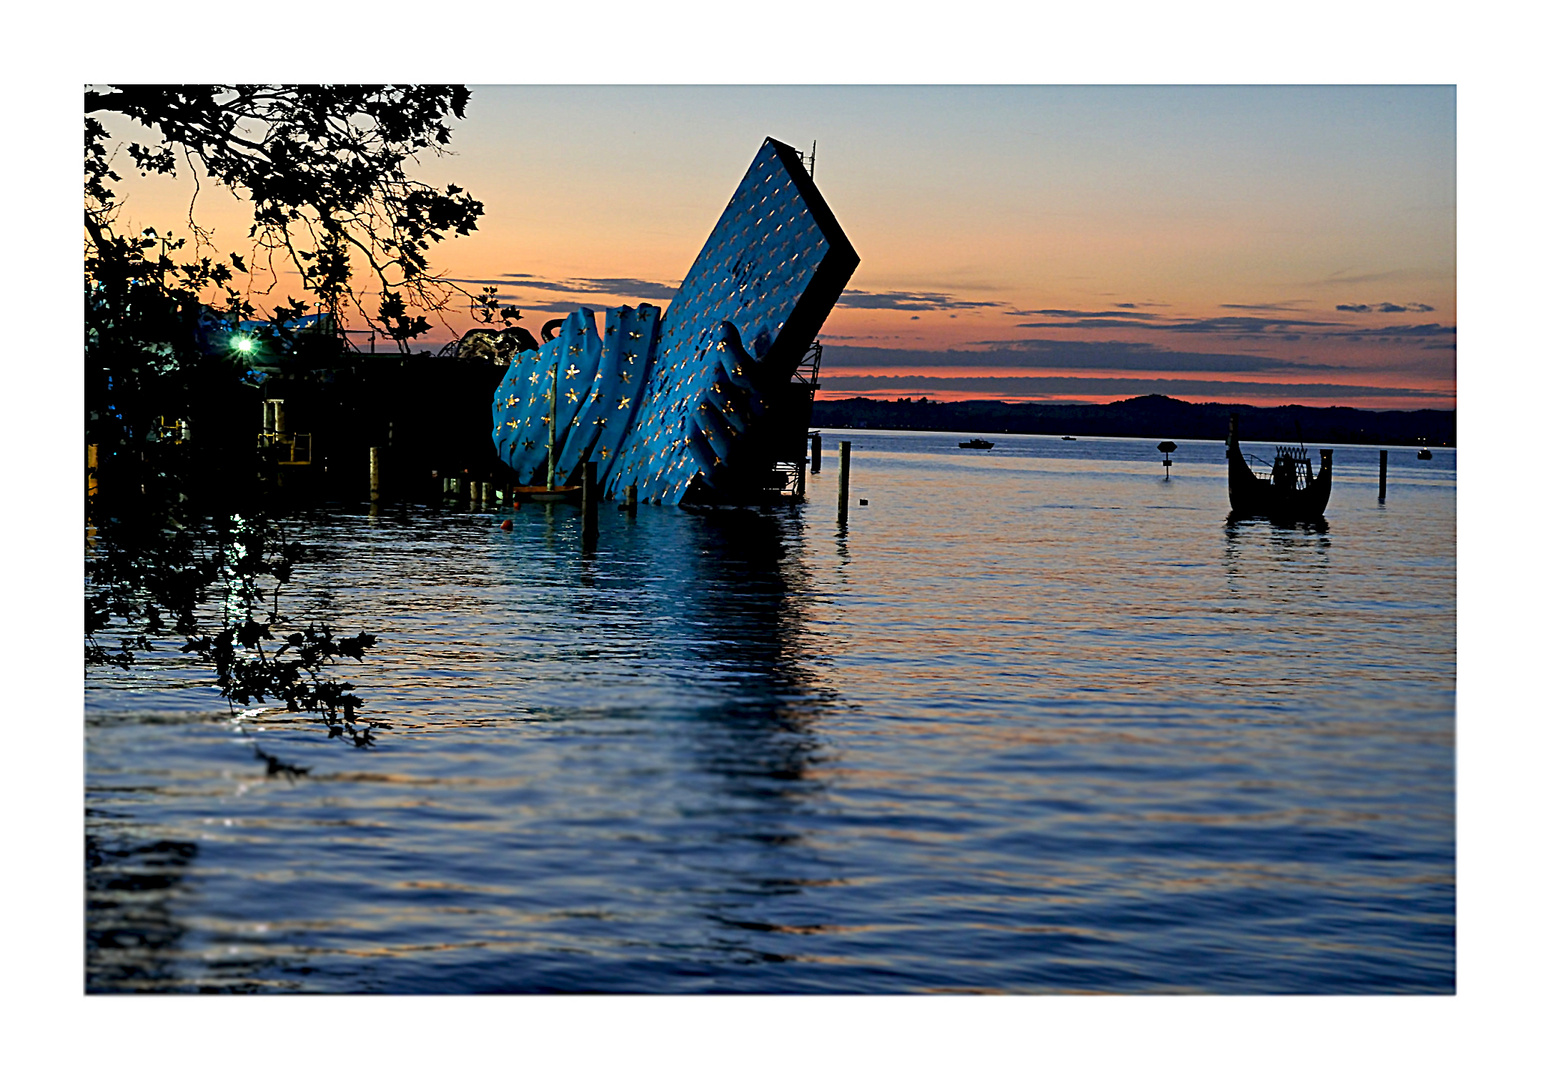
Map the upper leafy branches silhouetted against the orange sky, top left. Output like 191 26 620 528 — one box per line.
85 85 482 350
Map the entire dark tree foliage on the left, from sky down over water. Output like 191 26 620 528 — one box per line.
85 86 477 745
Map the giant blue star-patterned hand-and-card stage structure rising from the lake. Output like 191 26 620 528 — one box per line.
492 139 858 504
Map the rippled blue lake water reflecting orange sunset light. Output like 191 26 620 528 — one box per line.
85 431 1456 994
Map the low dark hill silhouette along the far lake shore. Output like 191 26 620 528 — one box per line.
811 394 1455 447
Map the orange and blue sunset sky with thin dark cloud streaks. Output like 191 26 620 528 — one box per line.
102 86 1456 408
